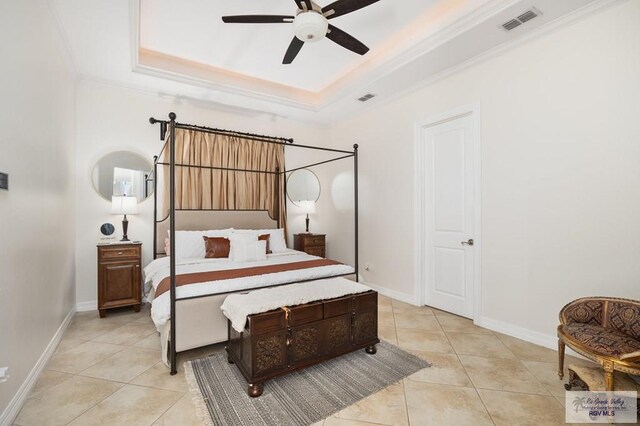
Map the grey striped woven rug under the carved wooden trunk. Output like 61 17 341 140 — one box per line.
184 342 430 426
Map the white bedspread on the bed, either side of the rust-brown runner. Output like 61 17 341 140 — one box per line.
144 250 355 331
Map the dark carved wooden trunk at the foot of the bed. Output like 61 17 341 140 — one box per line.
226 291 380 397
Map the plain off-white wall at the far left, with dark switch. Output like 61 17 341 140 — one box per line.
0 0 75 423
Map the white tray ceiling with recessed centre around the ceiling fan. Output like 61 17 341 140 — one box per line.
50 0 602 122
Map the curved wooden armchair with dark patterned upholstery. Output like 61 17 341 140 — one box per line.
558 297 640 391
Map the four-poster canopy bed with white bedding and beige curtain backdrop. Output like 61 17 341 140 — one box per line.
144 113 358 374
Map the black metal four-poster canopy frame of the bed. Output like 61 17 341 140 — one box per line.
148 112 358 375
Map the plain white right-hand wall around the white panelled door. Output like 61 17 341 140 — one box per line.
332 1 640 342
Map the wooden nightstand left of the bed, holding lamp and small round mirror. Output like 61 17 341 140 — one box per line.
98 243 142 318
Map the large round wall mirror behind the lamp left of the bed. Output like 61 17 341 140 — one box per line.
91 151 153 202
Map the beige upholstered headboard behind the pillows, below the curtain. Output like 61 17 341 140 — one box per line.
156 210 278 254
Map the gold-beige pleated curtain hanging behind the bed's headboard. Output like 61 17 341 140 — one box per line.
163 128 287 235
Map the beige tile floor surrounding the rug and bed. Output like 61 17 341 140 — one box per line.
15 296 586 426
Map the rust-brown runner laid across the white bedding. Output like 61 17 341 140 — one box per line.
155 259 341 297
